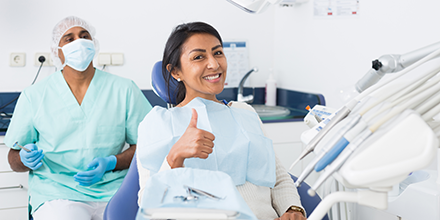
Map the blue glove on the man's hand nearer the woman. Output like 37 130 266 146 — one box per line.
73 155 116 186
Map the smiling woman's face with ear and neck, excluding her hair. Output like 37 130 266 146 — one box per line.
172 33 228 101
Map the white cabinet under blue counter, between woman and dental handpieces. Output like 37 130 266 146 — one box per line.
263 121 318 185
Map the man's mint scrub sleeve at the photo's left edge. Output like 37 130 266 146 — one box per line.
5 91 38 150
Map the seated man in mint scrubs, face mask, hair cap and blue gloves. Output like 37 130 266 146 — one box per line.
5 16 152 220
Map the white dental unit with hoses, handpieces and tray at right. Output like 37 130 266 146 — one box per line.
290 43 440 220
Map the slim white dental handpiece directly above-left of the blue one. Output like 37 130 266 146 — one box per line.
295 115 361 187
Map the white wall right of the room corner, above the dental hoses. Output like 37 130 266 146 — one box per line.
274 0 440 108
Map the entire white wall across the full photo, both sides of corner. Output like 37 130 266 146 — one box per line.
0 0 440 108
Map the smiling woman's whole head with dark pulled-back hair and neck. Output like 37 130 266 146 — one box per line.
162 22 227 104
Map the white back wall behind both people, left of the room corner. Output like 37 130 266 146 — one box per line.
0 0 274 92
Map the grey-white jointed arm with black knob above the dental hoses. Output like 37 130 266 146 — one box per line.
356 42 440 92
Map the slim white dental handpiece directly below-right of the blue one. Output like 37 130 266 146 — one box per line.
307 129 372 196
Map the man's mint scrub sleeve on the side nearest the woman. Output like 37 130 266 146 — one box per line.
125 81 152 145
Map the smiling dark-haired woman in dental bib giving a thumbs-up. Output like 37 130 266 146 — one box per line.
136 22 305 220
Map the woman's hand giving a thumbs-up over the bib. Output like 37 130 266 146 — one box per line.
167 109 215 168
